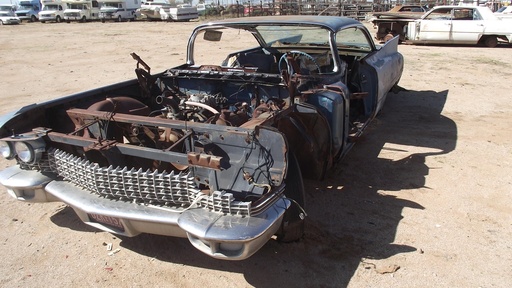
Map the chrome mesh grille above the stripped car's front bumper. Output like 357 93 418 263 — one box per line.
48 150 251 216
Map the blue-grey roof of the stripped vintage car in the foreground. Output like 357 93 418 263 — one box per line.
198 15 363 31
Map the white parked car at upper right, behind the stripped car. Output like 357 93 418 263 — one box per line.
407 6 512 47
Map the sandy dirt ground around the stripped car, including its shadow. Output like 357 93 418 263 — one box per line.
0 22 512 287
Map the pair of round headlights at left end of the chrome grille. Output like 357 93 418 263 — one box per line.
0 138 46 163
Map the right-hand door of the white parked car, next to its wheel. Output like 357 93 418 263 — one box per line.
451 7 485 44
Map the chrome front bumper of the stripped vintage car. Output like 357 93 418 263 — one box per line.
0 166 291 260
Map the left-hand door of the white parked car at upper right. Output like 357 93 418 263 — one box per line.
416 8 453 43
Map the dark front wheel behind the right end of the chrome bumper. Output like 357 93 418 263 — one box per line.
277 153 306 243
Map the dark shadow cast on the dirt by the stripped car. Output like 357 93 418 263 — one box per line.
52 91 457 287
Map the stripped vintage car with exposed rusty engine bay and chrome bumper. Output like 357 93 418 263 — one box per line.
0 16 403 260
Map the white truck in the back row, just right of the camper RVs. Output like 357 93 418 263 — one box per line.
99 0 142 22
